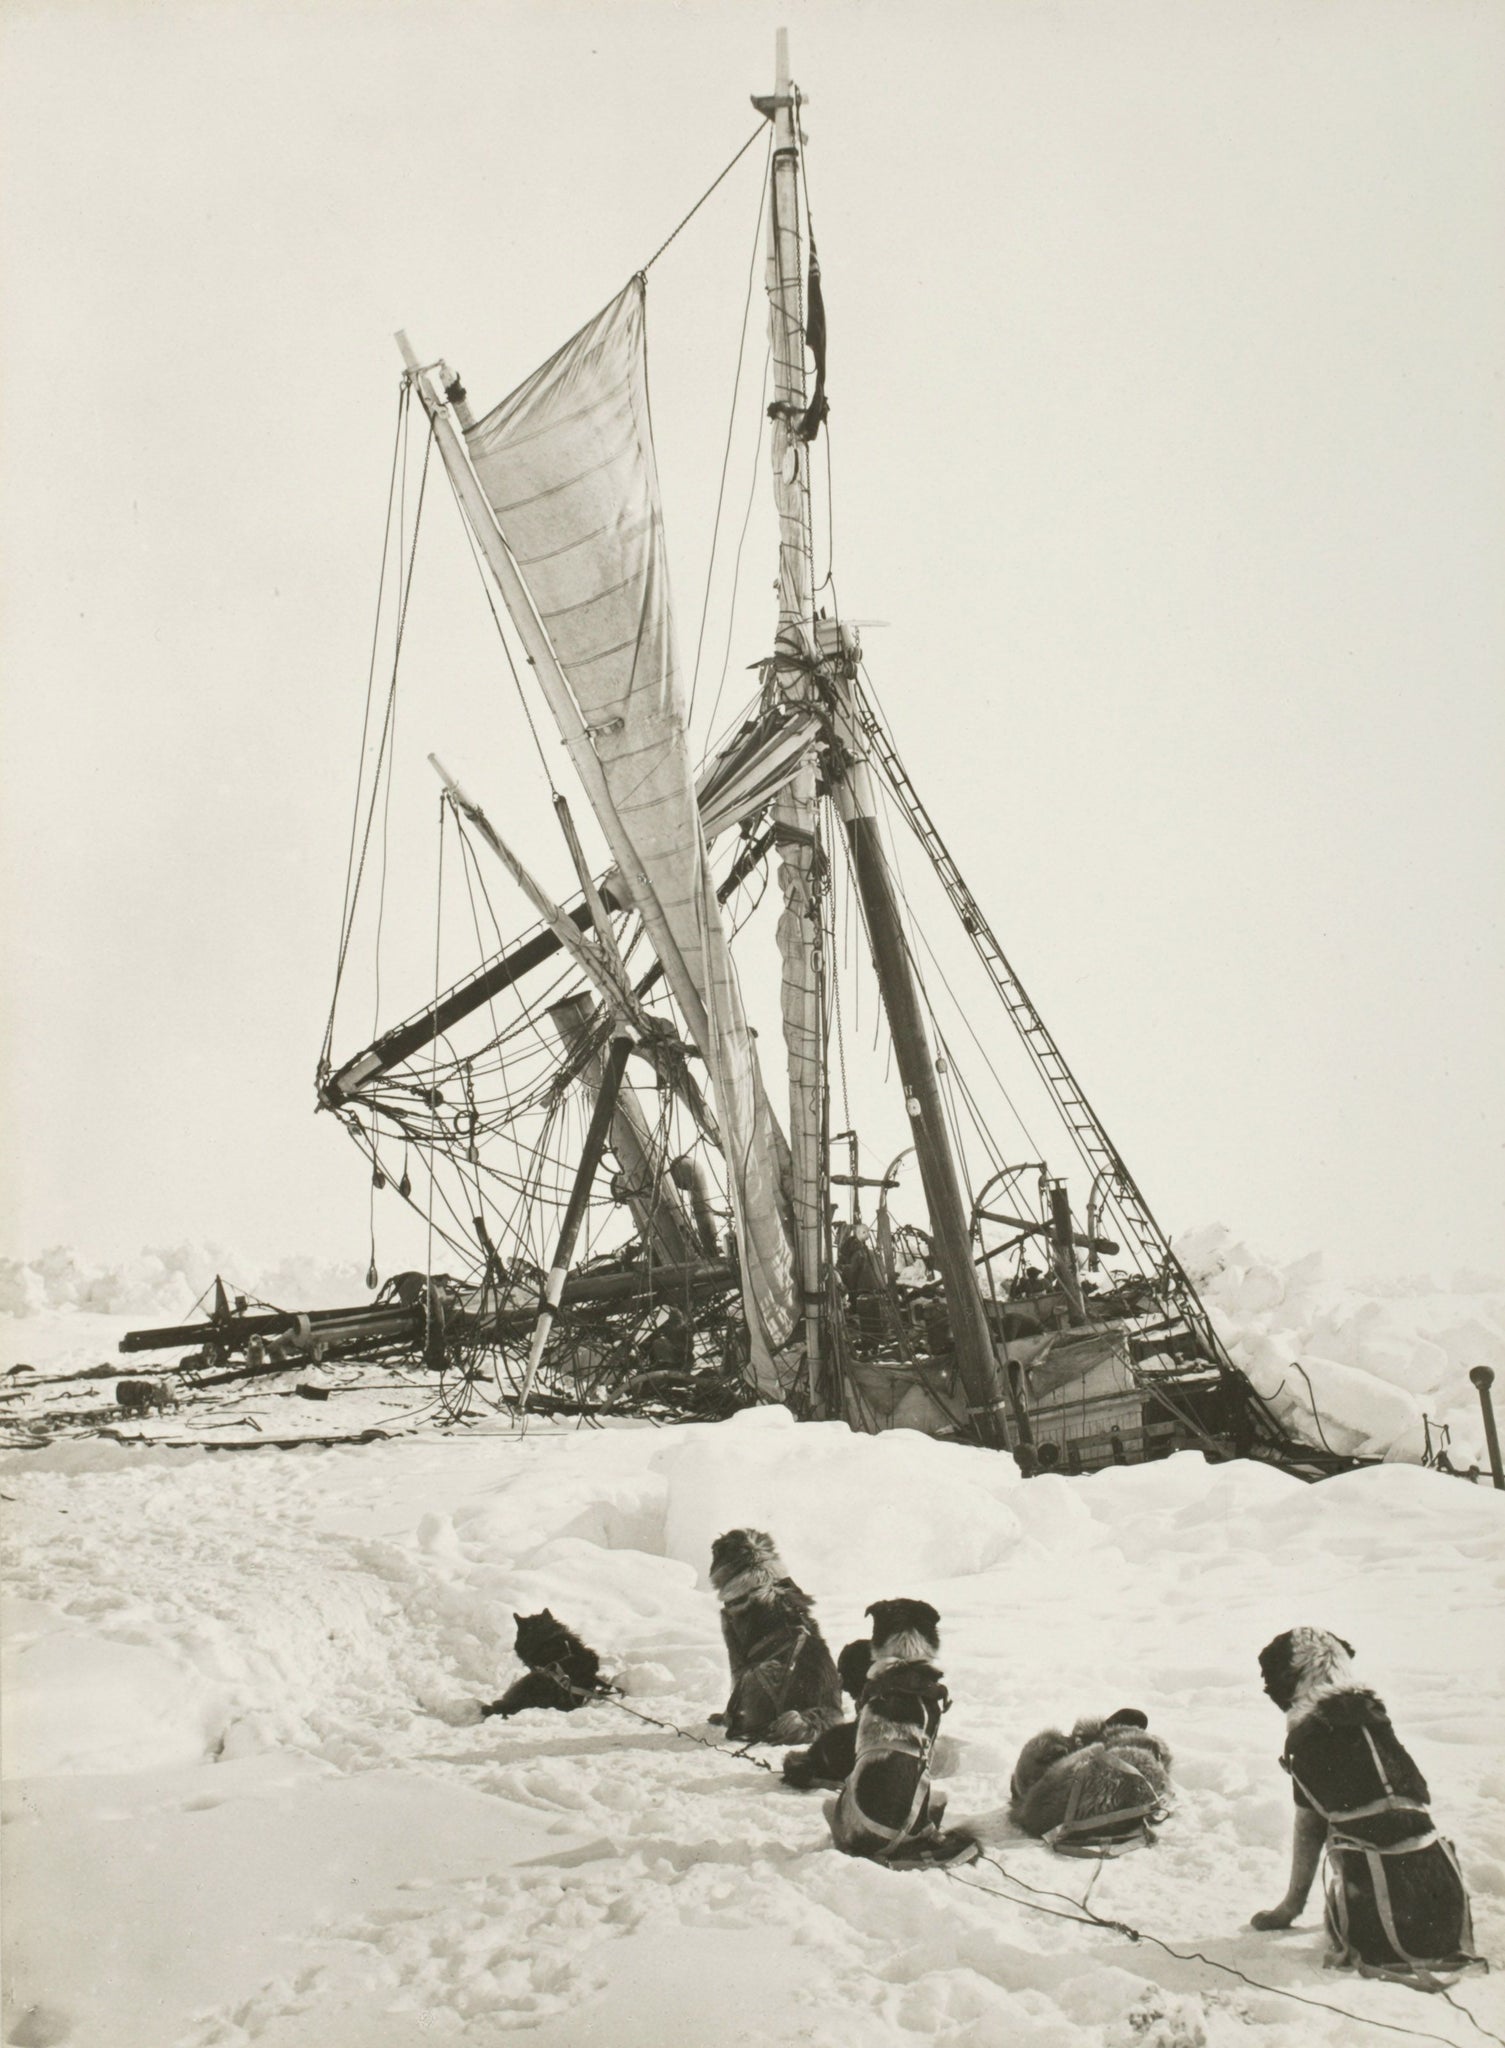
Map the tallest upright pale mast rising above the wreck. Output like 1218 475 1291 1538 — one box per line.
754 29 829 1413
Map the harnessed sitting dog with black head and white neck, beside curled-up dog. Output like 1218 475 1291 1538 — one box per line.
825 1599 979 1866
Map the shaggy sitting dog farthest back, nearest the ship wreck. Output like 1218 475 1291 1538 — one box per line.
711 1530 842 1743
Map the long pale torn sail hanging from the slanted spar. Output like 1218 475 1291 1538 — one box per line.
465 279 799 1395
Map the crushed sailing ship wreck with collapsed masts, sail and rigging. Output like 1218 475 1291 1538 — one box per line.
123 33 1349 1477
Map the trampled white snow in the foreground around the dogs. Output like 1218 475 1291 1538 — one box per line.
0 1409 1505 2048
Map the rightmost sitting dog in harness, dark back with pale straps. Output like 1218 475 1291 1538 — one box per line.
1251 1628 1480 1991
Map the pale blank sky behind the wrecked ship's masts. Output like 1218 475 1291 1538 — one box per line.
0 0 1505 1274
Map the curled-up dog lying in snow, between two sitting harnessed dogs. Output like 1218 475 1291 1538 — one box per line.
1009 1706 1171 1855
